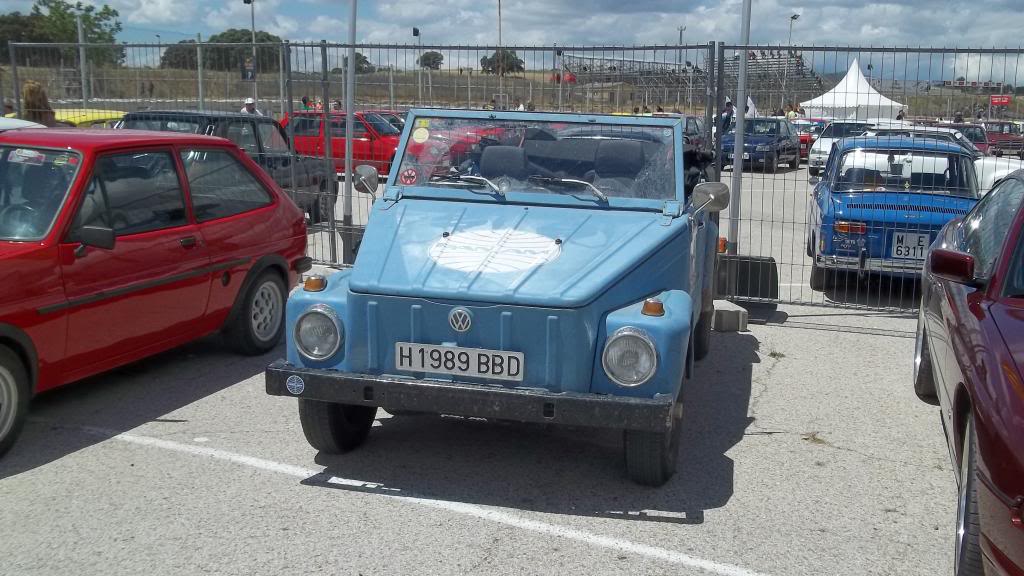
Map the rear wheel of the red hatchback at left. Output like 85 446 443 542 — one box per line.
226 270 288 356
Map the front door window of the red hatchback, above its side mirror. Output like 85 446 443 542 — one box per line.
69 152 188 241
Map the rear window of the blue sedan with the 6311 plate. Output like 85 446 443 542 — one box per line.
835 149 978 198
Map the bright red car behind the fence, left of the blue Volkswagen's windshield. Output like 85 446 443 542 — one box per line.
281 112 401 174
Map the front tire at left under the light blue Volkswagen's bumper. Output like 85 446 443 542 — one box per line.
299 398 377 454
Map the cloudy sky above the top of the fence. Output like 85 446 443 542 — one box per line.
6 0 1024 46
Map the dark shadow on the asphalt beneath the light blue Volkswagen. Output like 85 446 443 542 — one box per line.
304 333 760 524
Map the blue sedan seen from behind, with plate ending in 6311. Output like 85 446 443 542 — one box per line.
807 136 978 290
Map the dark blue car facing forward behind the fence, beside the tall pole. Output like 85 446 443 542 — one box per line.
722 118 800 173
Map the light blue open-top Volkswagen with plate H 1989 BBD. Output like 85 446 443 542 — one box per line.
266 110 728 486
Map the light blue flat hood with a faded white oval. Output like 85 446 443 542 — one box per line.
349 199 684 307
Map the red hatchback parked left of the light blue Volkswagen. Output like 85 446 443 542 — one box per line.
0 129 310 454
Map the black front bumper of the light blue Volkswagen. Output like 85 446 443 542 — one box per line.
266 361 673 431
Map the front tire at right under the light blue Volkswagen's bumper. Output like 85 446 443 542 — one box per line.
623 390 682 487
